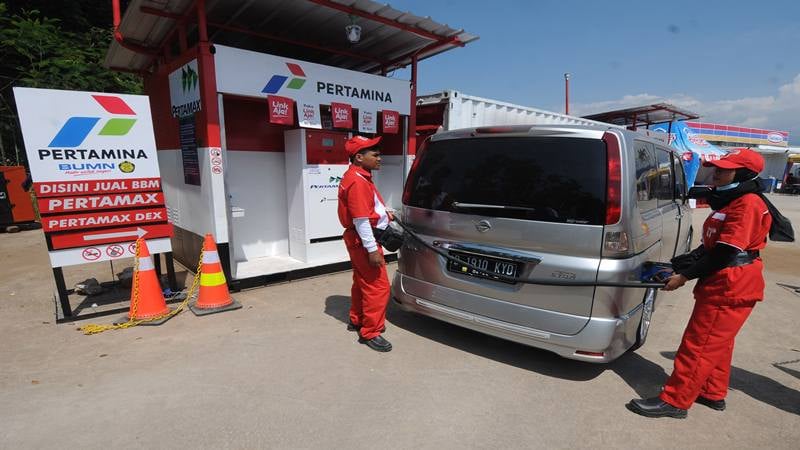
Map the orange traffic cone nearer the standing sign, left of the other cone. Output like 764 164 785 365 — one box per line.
114 238 172 325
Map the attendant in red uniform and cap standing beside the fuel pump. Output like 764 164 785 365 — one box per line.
339 136 392 352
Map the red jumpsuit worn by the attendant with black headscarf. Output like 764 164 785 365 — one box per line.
661 194 772 409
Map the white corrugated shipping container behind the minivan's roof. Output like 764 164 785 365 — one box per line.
417 91 613 131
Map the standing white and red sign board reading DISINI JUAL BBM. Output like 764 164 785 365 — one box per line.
14 88 172 267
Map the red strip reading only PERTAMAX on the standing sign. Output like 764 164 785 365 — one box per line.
38 192 164 214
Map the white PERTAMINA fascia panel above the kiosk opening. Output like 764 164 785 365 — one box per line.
214 45 411 115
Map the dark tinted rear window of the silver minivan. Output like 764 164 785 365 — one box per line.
406 137 606 225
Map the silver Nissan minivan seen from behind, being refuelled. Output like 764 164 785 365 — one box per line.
392 125 692 362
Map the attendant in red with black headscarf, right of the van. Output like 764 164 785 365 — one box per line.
627 149 772 418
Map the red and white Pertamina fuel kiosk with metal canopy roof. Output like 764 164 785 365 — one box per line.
106 0 477 288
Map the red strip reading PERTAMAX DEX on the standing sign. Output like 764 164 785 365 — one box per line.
42 208 167 232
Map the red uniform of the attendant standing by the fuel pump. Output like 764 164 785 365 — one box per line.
339 165 390 339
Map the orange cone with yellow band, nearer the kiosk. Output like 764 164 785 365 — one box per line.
189 234 242 316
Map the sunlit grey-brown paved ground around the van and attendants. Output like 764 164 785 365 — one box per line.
0 195 800 449
